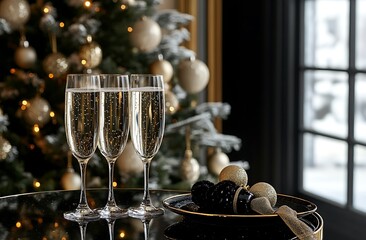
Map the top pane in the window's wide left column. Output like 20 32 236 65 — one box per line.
304 0 349 68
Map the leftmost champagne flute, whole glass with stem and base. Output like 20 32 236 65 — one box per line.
64 74 100 221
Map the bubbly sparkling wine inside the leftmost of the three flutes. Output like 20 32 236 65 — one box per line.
65 89 100 161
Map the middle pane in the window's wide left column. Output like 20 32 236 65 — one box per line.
304 71 348 137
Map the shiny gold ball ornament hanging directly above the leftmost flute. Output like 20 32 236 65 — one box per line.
79 41 103 69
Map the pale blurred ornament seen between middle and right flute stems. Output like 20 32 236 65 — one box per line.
116 141 144 176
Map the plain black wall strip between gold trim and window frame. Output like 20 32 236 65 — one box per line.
222 0 264 184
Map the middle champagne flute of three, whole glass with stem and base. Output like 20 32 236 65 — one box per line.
98 74 129 218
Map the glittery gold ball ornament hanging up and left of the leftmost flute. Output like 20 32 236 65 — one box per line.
43 52 69 78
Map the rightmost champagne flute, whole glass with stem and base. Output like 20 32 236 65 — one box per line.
128 74 165 219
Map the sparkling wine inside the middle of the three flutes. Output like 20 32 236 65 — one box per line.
99 88 129 160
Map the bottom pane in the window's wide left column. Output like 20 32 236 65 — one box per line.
303 134 347 204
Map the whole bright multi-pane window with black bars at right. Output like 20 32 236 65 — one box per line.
300 0 366 214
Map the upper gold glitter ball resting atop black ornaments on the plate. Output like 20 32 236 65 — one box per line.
219 165 248 187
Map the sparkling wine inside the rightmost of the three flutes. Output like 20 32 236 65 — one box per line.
130 87 165 161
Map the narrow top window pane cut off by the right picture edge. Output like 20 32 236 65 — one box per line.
356 0 366 69
